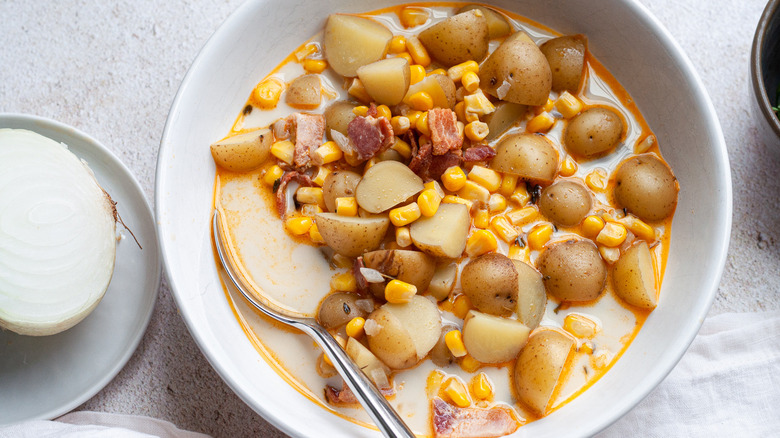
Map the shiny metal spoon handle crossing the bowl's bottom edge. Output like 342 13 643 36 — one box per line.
294 323 415 438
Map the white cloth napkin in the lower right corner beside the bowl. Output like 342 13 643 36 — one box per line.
598 312 780 438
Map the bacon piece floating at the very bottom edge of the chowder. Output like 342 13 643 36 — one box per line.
433 397 520 438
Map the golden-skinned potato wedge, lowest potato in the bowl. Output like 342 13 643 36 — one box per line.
513 329 576 415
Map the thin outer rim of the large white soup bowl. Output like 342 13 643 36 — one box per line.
155 0 732 436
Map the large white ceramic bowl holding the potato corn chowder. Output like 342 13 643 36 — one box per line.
156 0 732 437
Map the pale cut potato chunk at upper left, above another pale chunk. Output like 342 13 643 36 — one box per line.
322 14 393 77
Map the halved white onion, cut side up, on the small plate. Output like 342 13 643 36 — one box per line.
0 129 116 336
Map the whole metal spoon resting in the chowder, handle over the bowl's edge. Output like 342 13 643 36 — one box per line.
213 208 415 438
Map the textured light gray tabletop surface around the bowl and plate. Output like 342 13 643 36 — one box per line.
0 0 780 437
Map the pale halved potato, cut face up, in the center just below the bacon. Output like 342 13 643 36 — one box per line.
355 161 425 213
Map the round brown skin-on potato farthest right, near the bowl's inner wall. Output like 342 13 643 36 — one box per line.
614 154 680 222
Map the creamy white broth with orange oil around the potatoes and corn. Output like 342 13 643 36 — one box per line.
215 4 671 435
